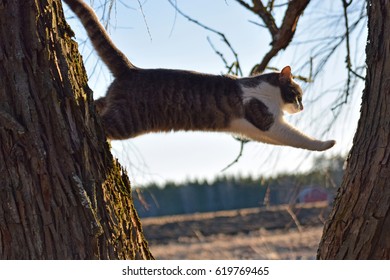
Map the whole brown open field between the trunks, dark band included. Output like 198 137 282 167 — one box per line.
142 203 329 260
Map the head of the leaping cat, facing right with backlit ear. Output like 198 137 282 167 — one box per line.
278 66 303 114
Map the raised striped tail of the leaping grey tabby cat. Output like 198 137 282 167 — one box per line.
64 0 136 77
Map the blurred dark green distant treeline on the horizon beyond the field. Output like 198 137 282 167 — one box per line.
133 156 344 217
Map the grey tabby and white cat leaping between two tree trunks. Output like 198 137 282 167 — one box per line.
64 0 335 151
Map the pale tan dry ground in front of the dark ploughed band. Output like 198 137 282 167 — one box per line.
151 226 322 260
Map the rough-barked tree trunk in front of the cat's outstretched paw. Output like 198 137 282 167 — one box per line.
317 0 390 259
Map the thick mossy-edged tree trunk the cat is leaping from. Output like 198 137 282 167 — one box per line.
0 0 153 259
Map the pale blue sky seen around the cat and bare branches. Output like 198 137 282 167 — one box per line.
65 0 366 186
